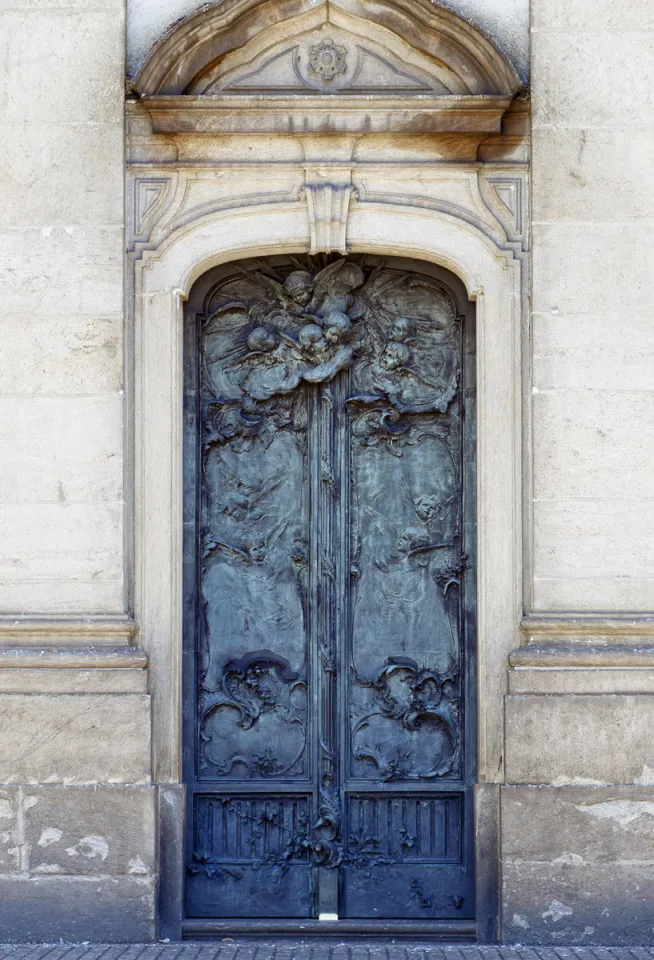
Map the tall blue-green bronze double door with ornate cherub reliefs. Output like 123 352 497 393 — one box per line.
185 256 476 926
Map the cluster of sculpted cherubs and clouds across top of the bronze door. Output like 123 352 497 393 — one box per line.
205 259 458 413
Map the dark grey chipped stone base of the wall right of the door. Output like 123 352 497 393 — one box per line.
501 788 654 944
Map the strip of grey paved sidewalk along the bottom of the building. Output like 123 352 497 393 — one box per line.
0 939 654 960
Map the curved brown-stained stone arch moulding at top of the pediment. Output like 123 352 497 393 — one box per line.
134 0 520 98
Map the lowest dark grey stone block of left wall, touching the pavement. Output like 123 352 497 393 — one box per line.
0 876 155 943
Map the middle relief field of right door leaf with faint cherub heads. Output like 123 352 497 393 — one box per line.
353 424 461 670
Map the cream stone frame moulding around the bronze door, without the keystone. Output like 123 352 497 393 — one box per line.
130 193 527 942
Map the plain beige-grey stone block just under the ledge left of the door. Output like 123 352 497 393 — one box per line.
0 694 150 784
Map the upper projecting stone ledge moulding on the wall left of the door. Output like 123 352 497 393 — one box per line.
0 615 136 650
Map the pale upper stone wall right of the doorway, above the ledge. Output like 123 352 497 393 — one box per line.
532 0 654 611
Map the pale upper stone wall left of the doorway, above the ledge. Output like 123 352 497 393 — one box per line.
0 0 124 613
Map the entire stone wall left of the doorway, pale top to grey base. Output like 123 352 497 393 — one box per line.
0 0 154 940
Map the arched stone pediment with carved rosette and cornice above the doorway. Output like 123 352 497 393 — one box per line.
135 0 520 133
